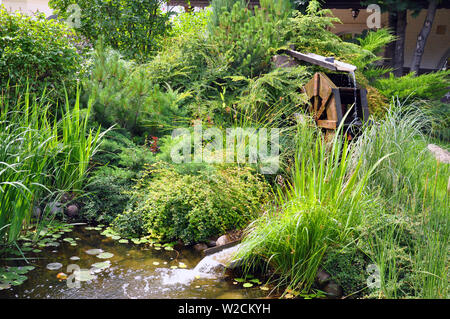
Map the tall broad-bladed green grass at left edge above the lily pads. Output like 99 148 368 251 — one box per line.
0 89 102 242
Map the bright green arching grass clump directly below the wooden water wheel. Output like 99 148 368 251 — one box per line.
238 117 382 292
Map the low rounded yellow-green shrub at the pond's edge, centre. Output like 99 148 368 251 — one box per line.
113 167 268 244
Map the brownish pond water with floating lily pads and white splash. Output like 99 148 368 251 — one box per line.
0 226 268 299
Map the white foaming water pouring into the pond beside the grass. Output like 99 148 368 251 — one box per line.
161 245 239 285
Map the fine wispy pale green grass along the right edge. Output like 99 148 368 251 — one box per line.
354 102 450 298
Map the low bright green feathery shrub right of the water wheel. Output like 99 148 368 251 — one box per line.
375 70 450 101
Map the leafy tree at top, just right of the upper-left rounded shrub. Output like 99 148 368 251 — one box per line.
49 0 170 60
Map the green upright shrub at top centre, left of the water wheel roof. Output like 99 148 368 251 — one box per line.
209 0 292 77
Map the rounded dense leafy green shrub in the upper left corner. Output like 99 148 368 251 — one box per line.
0 7 81 100
